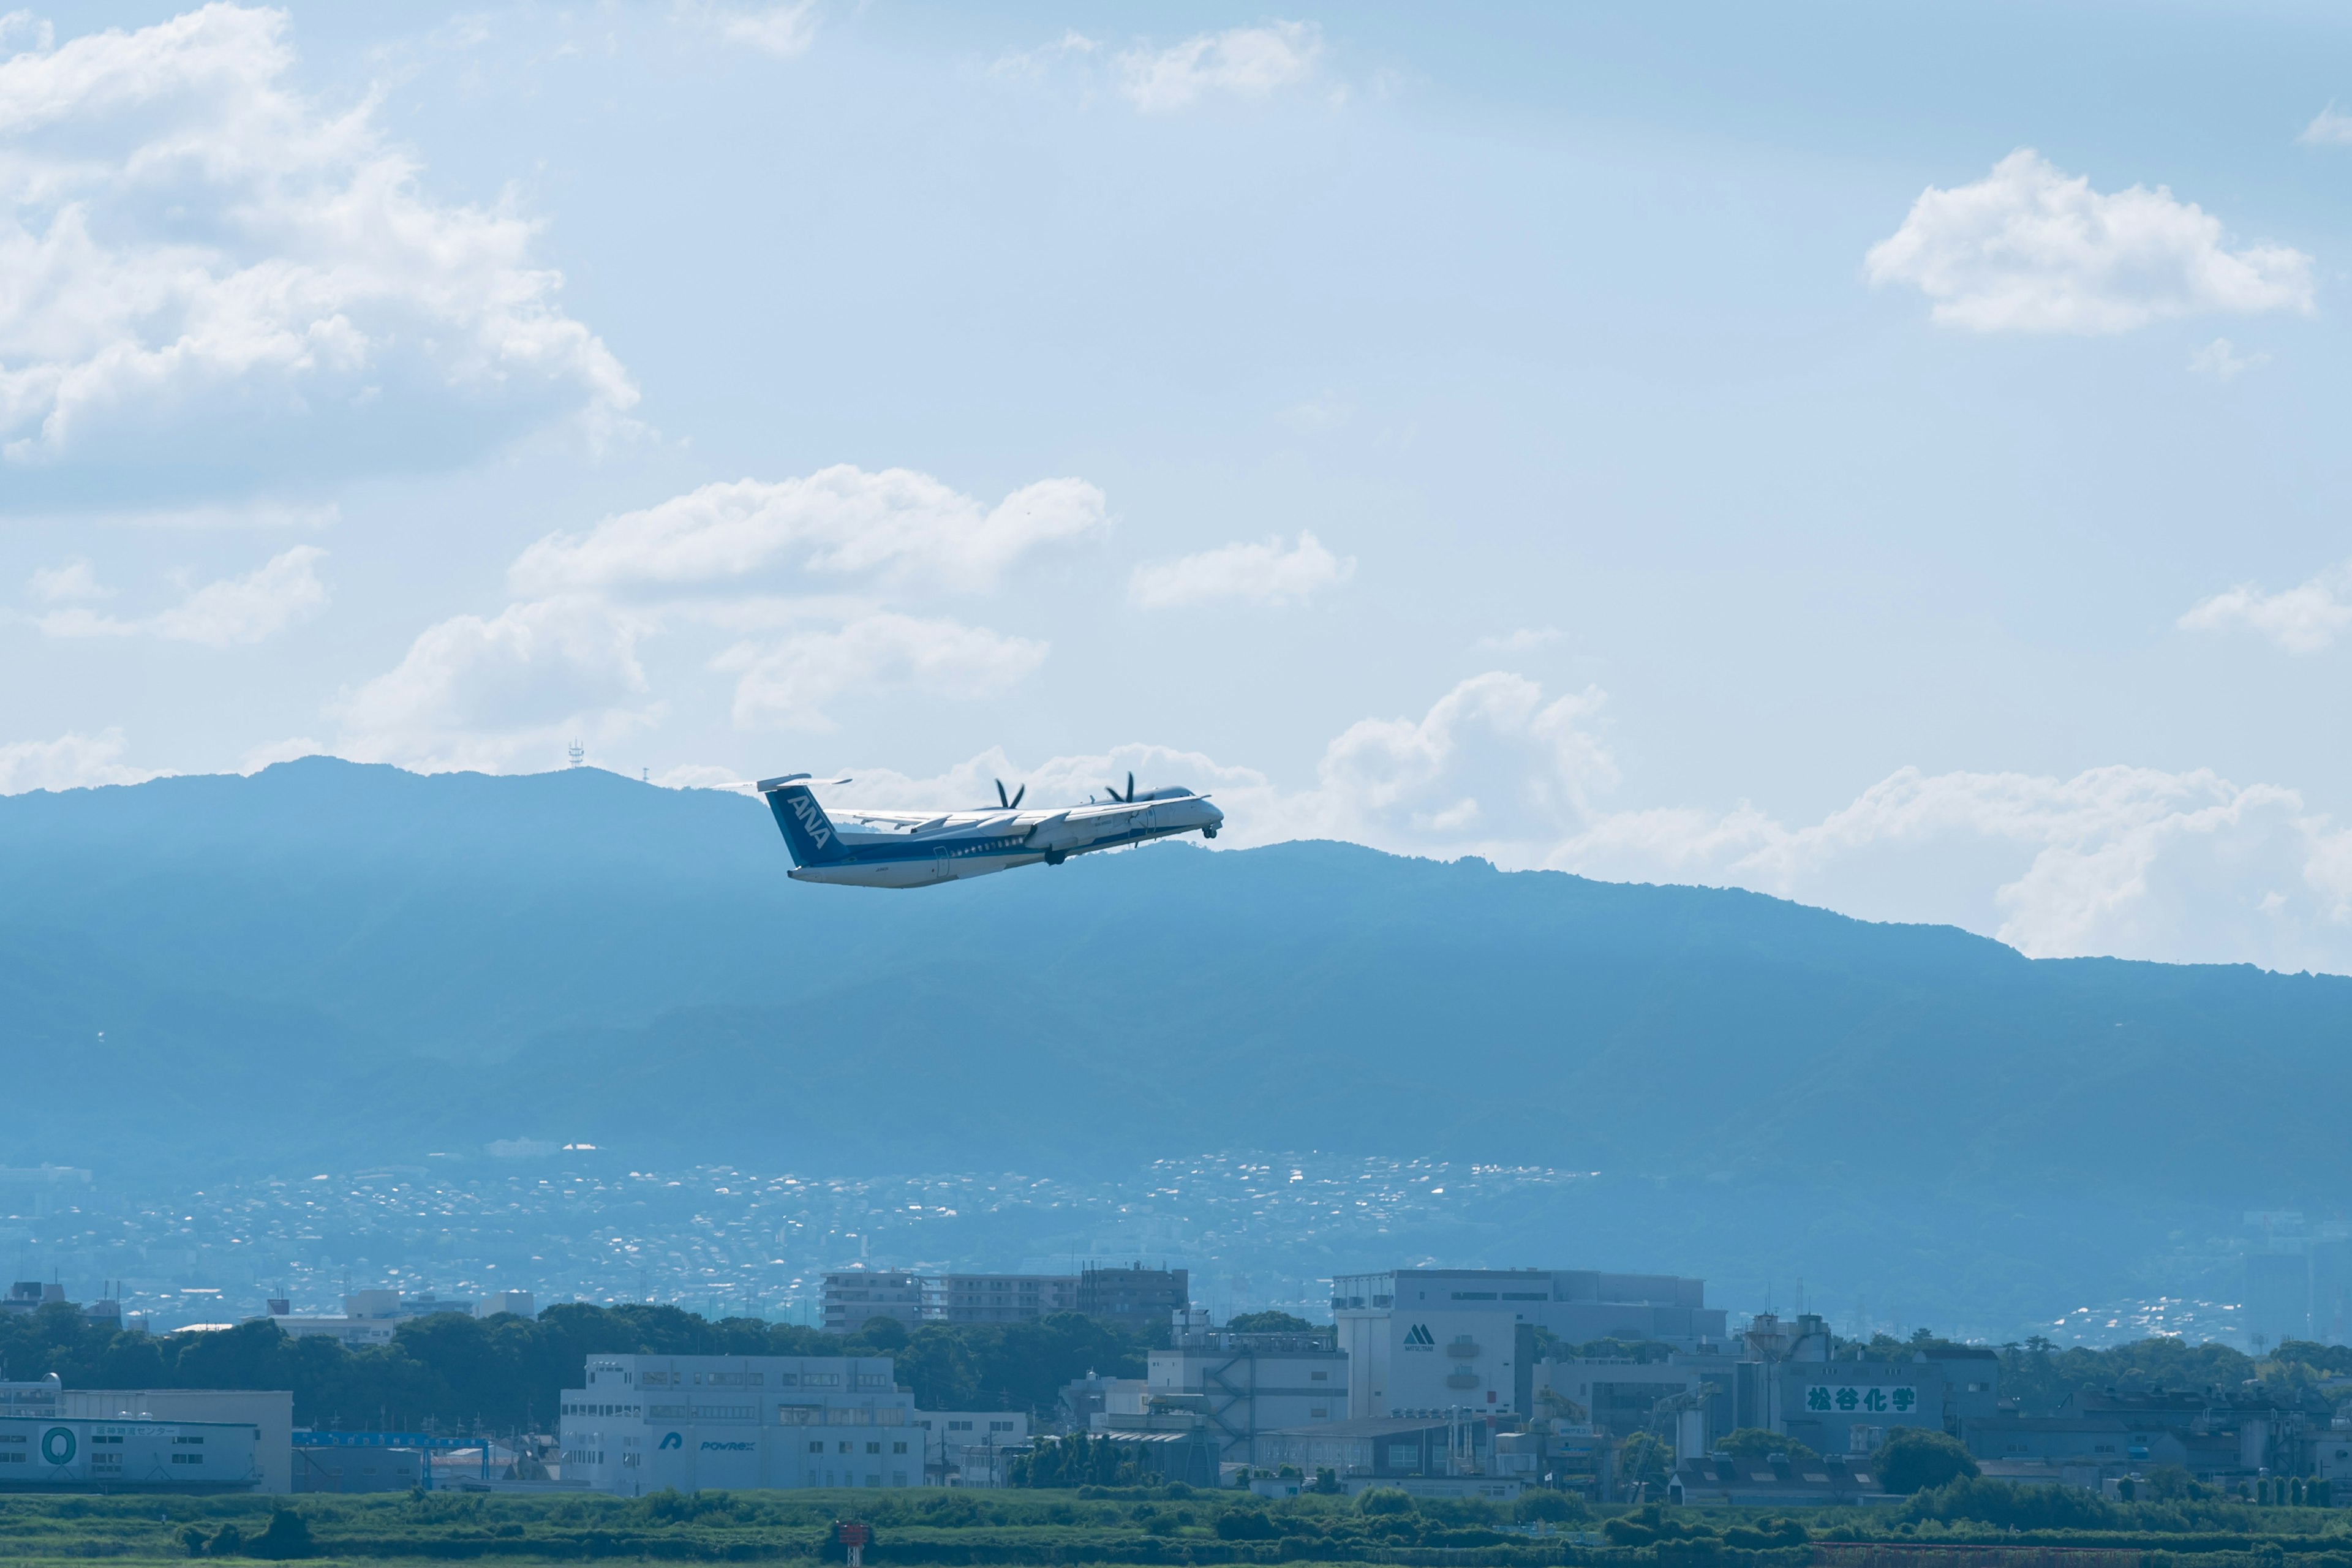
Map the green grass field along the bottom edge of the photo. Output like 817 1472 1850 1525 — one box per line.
13 1486 2352 1568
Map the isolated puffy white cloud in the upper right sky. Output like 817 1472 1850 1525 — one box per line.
1863 148 2312 334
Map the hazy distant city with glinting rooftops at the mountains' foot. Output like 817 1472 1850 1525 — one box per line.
0 1140 2352 1349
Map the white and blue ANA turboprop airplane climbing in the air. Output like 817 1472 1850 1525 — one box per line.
755 774 1226 886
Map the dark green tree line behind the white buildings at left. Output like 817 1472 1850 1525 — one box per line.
0 1302 1148 1431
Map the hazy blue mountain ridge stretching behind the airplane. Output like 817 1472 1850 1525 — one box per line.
0 760 2352 1201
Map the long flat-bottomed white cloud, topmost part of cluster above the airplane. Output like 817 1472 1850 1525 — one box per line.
508 463 1108 595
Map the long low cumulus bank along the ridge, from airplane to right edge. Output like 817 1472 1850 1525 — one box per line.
840 673 2352 973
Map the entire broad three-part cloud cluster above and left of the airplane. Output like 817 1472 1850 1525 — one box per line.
331 466 1091 766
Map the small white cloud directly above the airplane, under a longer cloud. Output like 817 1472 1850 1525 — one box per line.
713 611 1047 731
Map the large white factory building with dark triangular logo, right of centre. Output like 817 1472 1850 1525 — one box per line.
1331 1270 1724 1417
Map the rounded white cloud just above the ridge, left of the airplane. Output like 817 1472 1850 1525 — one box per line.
330 600 661 771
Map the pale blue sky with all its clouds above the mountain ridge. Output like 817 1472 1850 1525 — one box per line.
0 0 2352 971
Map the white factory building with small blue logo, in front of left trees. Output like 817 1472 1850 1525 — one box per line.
557 1357 927 1498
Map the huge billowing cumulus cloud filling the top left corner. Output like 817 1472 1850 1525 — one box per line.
0 5 638 503
